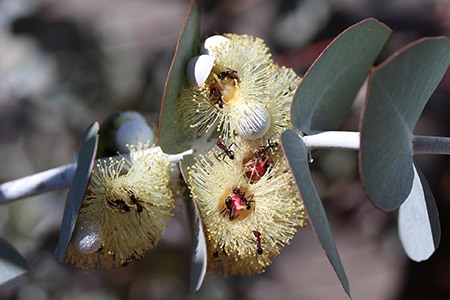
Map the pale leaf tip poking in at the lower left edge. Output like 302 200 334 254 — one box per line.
0 238 29 286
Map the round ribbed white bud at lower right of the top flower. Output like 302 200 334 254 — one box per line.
236 103 270 140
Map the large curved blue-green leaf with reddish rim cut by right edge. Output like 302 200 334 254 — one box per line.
359 37 450 211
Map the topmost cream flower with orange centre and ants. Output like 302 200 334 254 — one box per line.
178 34 300 141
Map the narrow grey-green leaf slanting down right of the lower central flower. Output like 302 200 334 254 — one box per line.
281 129 350 297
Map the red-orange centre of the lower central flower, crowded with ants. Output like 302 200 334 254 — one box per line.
218 186 255 221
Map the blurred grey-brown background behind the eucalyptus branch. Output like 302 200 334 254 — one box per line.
0 0 450 300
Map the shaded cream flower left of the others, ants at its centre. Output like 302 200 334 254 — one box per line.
65 146 174 269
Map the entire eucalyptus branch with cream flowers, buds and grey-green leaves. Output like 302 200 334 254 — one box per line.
0 0 450 297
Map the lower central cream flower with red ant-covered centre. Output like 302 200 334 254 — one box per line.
188 143 306 276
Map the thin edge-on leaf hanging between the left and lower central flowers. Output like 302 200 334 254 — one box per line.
180 155 207 291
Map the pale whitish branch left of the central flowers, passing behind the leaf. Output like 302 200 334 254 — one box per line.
0 147 192 204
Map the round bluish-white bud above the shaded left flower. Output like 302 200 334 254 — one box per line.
116 120 155 153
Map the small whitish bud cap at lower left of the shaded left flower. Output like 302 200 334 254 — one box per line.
72 224 102 254
